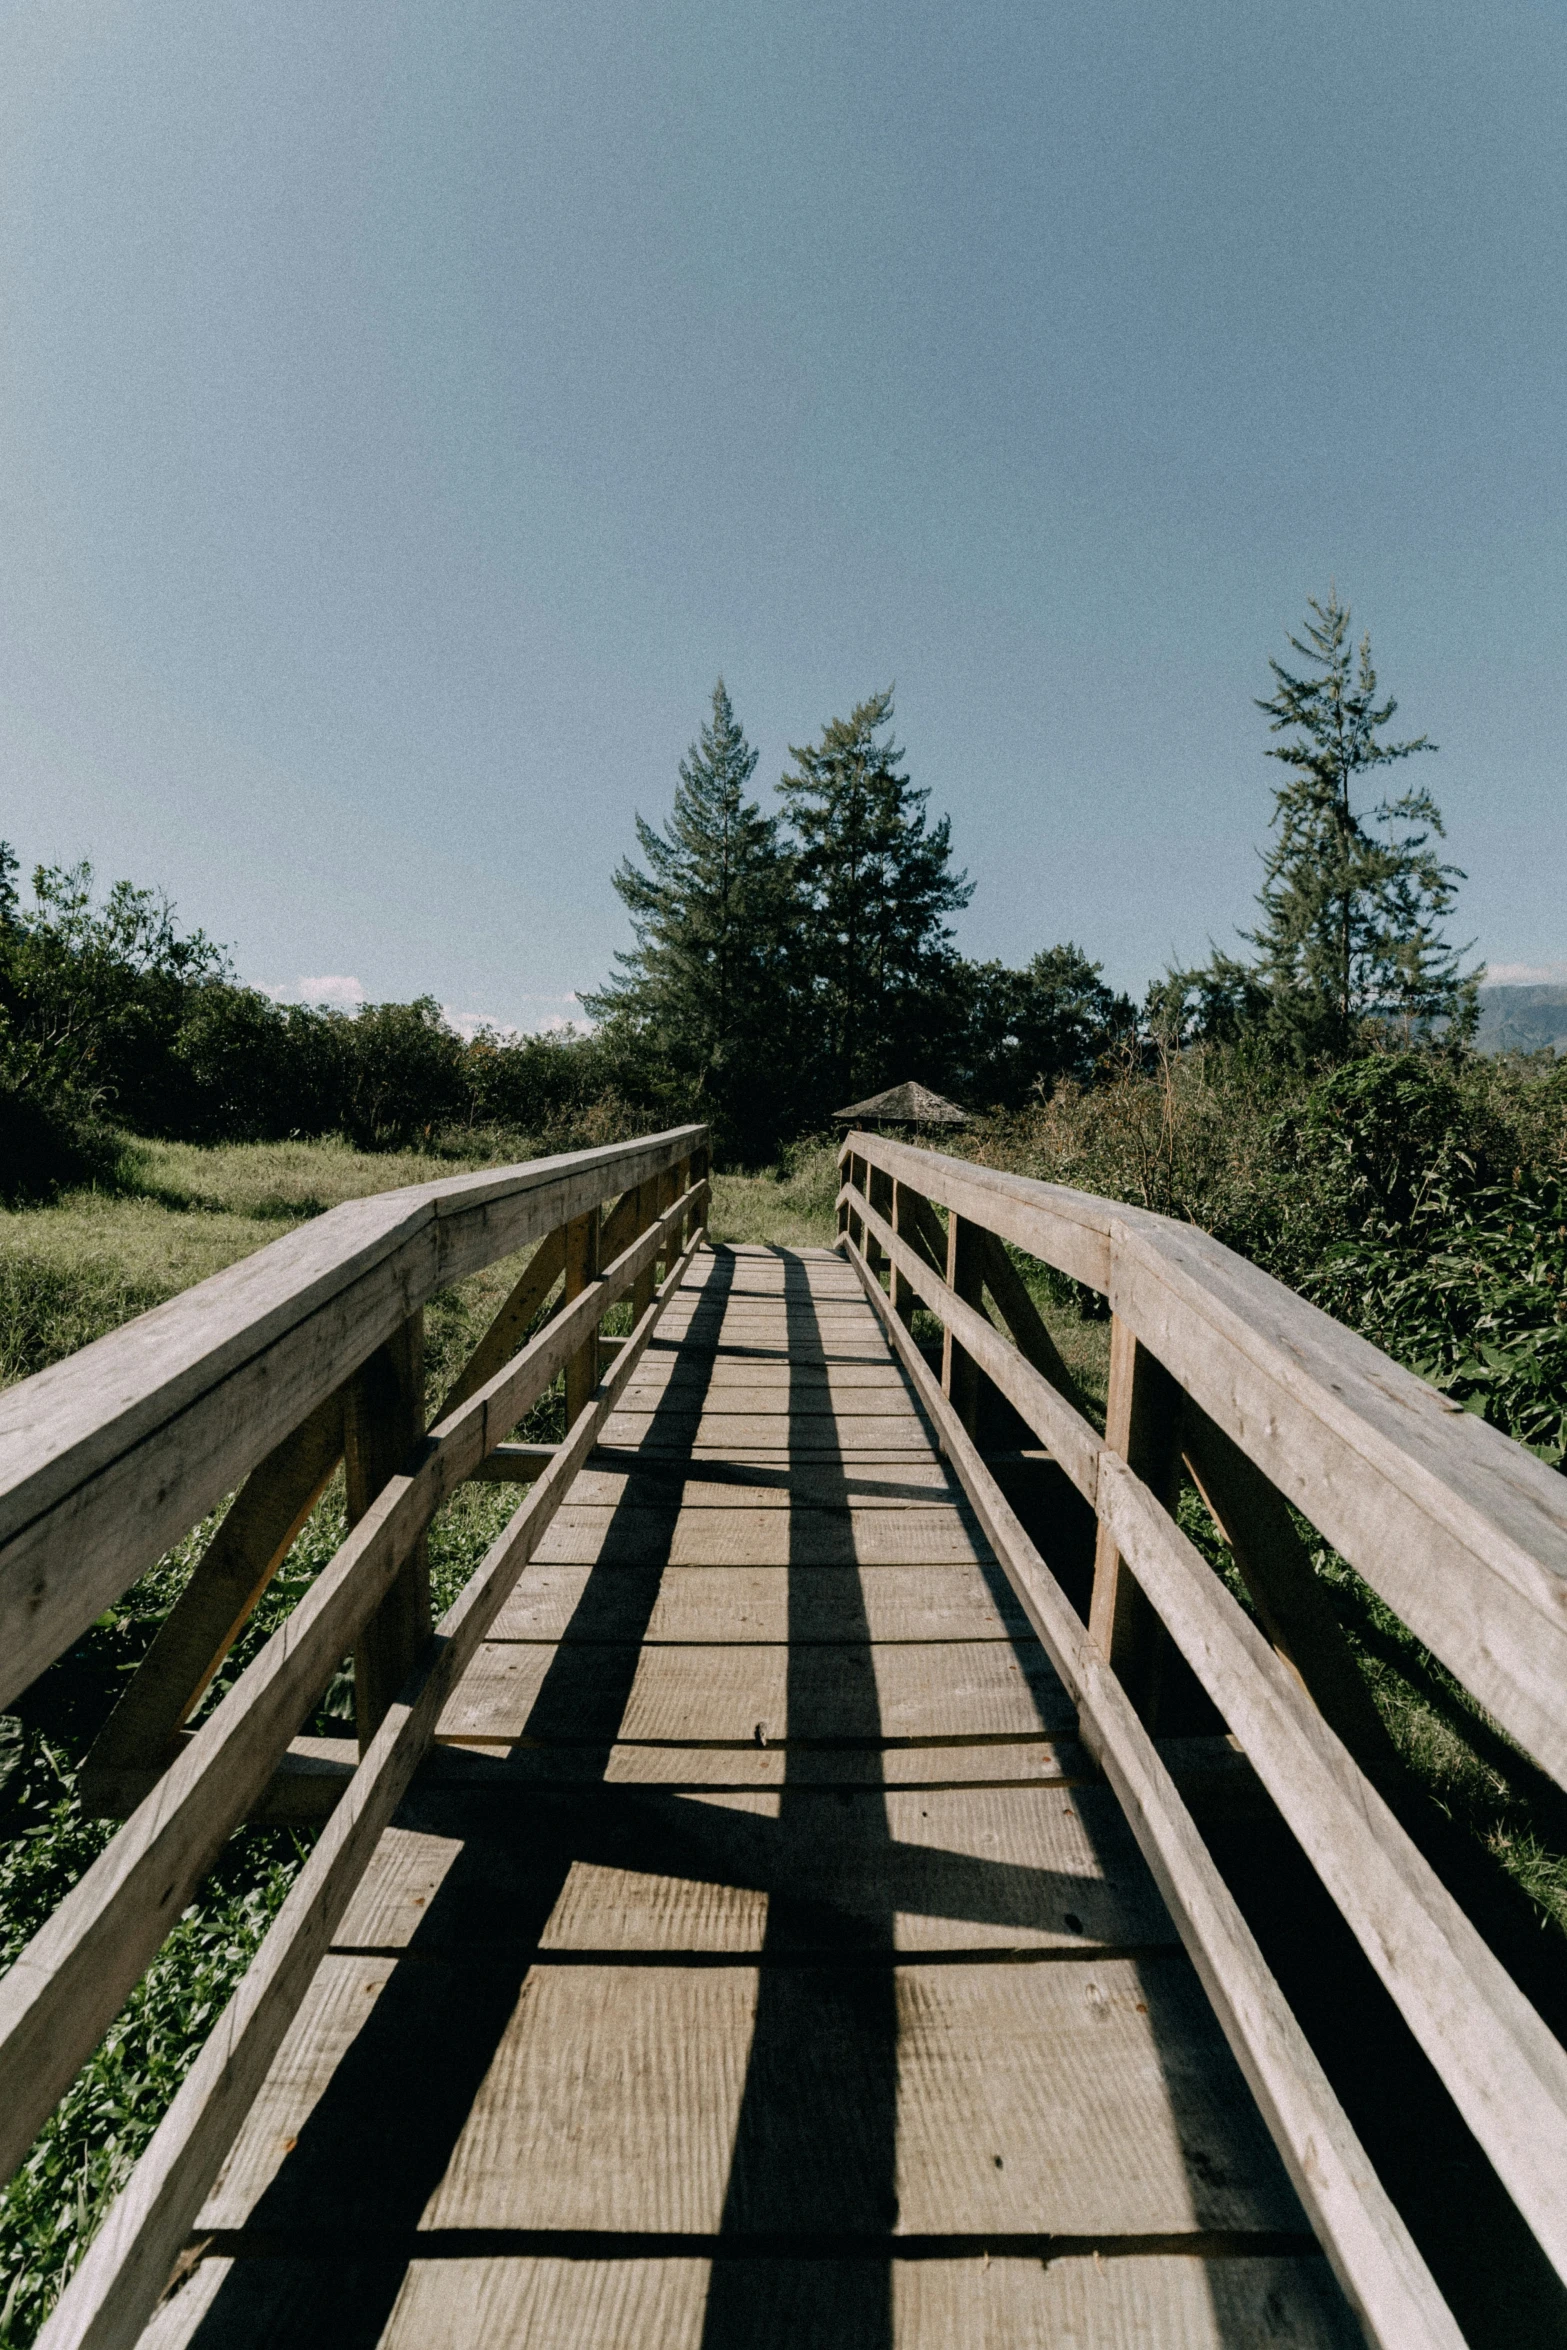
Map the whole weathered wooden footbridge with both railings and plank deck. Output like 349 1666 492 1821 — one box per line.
0 1128 1567 2350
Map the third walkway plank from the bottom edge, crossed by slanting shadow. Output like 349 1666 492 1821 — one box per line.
321 1781 1179 1964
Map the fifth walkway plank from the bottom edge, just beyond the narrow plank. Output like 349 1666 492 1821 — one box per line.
439 1640 1074 1751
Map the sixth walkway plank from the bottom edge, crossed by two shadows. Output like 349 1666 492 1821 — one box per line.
493 1569 1031 1643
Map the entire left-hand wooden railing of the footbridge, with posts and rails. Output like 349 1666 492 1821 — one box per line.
0 1126 707 2345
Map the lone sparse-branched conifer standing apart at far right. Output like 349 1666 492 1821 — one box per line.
1245 590 1475 1058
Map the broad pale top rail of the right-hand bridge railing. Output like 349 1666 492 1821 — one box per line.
843 1133 1567 1786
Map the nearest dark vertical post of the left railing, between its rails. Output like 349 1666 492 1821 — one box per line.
343 1309 430 1753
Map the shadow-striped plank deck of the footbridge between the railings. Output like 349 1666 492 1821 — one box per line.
143 1248 1360 2350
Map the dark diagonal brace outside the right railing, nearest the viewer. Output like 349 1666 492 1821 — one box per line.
1182 1396 1405 1793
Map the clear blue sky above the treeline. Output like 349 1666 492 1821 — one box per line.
0 0 1567 1025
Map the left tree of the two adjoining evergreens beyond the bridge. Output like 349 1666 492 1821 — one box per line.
583 679 789 1156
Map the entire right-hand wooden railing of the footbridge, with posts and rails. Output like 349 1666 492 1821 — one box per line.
839 1133 1567 2343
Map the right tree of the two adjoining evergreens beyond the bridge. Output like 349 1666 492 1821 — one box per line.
778 689 973 1109
